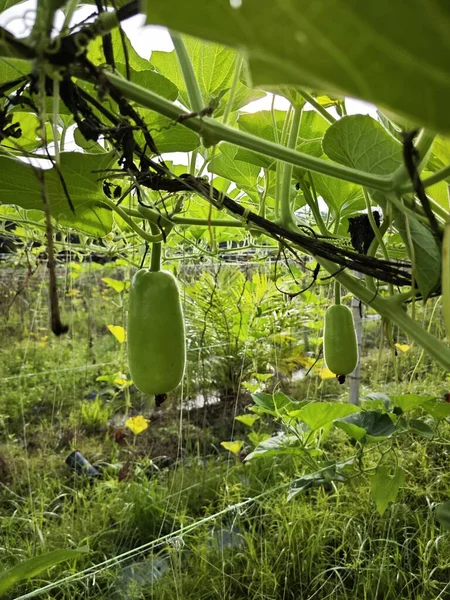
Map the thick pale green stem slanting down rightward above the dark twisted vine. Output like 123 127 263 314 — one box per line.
104 71 394 191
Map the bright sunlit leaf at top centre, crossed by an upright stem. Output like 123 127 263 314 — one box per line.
151 37 264 117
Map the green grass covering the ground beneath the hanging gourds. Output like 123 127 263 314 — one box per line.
0 270 450 600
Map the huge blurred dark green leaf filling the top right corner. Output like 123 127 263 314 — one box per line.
146 0 450 132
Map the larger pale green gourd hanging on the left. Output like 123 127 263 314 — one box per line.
127 269 186 397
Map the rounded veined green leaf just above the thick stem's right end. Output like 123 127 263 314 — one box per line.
323 115 402 175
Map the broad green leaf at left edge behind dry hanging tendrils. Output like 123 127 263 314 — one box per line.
0 152 115 237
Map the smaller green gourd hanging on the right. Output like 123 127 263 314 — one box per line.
323 304 358 376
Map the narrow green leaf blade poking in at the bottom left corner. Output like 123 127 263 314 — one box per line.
0 548 88 596
